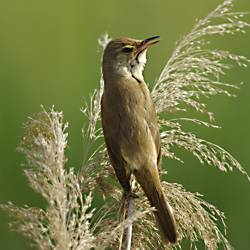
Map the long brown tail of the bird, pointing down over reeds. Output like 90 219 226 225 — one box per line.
134 167 178 244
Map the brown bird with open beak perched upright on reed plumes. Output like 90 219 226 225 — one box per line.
101 36 177 243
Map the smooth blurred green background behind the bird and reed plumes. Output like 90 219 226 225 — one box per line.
0 0 250 250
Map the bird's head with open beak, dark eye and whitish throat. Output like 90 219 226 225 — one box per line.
103 36 159 81
